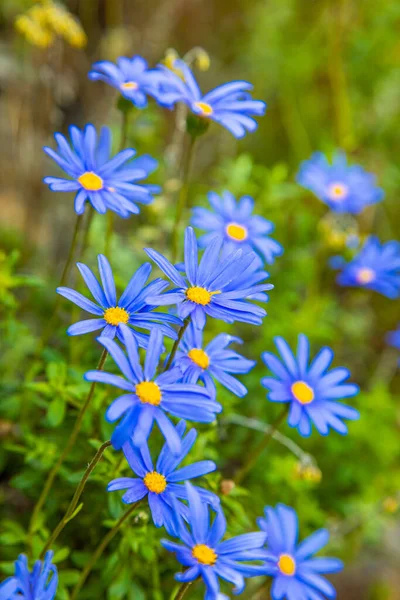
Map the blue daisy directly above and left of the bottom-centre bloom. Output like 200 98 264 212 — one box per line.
107 421 220 536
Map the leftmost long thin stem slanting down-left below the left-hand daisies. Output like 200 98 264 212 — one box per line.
29 349 108 539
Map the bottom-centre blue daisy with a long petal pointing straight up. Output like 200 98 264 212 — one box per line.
161 483 266 600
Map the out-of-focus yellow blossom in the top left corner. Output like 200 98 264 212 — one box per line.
15 0 87 48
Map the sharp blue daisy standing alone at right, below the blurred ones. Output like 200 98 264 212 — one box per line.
261 334 360 437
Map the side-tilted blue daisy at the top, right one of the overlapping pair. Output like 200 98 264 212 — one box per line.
159 60 266 138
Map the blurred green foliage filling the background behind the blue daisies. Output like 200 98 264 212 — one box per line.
0 0 400 600
